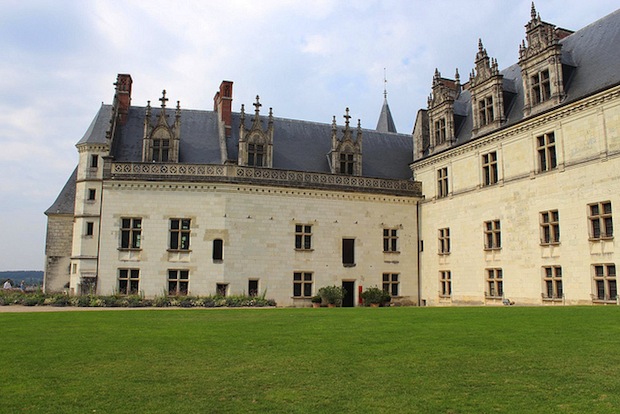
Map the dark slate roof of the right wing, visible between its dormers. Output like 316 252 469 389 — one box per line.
416 10 620 161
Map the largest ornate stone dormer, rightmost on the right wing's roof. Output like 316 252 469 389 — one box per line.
519 2 572 116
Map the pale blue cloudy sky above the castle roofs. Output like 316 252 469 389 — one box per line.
0 0 618 271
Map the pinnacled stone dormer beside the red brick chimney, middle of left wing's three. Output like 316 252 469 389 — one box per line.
237 95 273 168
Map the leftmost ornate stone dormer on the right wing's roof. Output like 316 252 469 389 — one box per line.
428 69 461 153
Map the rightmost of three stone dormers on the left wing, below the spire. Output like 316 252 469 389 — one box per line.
329 108 362 175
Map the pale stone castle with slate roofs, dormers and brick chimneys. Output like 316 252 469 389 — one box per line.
44 5 620 306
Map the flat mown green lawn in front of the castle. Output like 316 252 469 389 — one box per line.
0 306 620 413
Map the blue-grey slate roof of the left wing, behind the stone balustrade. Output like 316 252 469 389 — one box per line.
108 103 413 179
